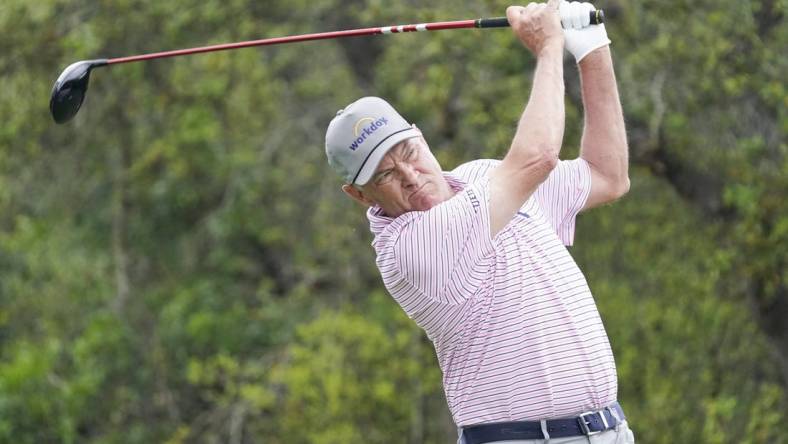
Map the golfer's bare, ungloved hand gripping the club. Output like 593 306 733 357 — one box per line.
506 0 564 57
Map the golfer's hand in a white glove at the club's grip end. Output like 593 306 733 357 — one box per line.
558 0 610 63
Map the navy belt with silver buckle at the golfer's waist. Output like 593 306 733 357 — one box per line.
462 402 626 444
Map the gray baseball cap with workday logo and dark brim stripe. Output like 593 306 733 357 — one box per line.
326 97 421 185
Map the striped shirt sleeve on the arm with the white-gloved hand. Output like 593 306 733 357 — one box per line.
534 157 591 245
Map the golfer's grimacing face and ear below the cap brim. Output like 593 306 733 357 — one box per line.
344 136 454 217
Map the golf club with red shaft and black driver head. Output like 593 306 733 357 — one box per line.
49 9 605 123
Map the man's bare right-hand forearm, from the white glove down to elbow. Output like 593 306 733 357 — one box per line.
579 46 629 193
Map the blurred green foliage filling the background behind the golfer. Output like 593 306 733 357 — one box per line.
0 0 788 444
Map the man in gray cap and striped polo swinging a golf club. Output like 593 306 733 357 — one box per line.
326 0 634 444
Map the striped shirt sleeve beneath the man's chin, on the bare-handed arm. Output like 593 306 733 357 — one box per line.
378 179 493 318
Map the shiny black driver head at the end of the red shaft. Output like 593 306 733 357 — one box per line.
49 59 107 123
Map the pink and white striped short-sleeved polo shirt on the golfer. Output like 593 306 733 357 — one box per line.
367 159 618 427
